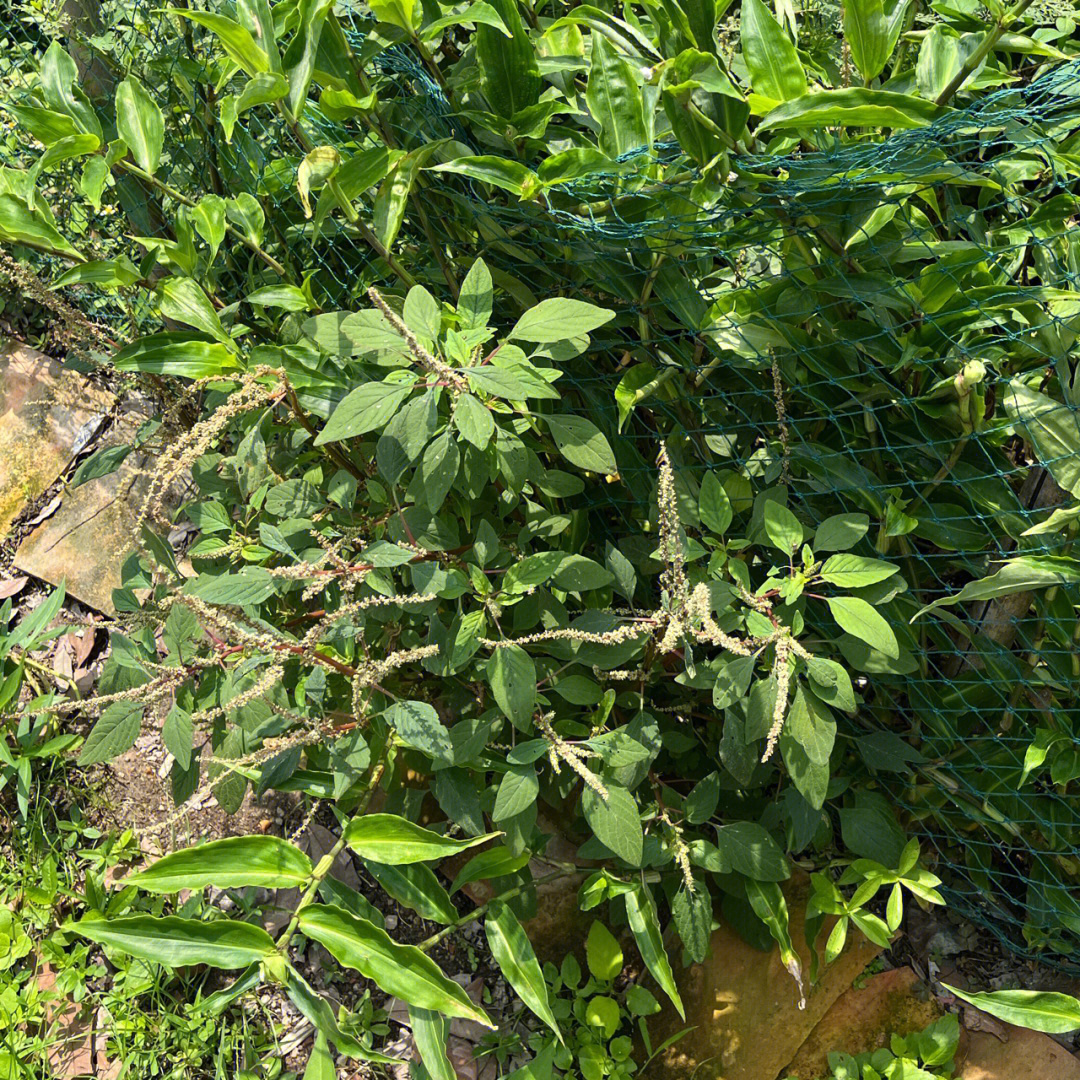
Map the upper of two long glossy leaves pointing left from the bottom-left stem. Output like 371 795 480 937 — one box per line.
124 836 311 892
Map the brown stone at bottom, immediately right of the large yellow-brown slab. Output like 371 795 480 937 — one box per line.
783 968 942 1080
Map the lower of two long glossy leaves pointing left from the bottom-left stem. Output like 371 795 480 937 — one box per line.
75 915 274 968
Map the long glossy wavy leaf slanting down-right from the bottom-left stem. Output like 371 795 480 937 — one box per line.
299 902 495 1028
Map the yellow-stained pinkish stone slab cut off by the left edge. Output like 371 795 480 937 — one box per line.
0 341 113 540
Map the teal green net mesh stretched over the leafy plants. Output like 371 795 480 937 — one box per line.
6 0 1080 970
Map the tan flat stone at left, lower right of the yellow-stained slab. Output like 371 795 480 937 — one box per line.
14 416 172 615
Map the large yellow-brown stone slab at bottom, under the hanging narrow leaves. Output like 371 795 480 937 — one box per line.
649 877 880 1080
